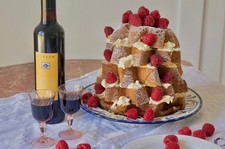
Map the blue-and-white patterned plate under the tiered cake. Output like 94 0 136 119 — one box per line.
81 83 203 124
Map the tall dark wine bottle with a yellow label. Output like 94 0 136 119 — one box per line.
34 0 65 124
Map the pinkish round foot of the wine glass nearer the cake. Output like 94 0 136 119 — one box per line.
59 129 82 140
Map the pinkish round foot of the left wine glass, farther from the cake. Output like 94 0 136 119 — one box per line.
31 137 57 148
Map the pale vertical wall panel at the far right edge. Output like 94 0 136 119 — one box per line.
200 0 225 84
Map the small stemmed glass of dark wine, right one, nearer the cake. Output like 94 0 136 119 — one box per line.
59 84 83 140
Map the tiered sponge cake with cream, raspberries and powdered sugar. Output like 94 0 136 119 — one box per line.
89 6 188 120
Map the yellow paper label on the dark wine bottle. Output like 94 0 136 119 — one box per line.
35 52 58 100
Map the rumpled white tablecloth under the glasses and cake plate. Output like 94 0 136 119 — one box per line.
0 67 225 149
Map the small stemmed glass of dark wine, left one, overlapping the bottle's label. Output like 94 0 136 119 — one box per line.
28 89 57 148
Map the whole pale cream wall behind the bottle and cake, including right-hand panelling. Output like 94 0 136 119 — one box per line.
0 0 225 84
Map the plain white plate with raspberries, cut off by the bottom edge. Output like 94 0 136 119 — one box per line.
121 135 222 149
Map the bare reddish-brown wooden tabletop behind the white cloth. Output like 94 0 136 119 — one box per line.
0 59 191 98
